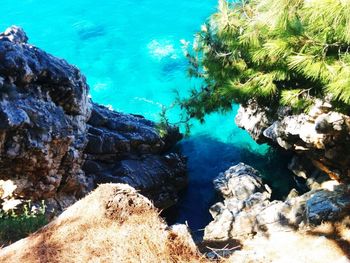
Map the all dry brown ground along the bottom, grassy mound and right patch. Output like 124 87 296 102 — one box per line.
0 184 350 263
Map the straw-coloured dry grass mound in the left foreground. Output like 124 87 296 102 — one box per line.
0 184 206 263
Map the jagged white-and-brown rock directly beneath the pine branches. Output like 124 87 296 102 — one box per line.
236 100 350 183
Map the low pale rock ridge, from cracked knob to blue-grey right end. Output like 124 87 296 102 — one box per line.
204 163 350 241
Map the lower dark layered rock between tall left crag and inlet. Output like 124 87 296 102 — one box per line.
83 104 187 208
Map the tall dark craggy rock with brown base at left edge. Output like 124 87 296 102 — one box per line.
0 27 92 207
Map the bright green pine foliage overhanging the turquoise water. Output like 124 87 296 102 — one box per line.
179 0 350 120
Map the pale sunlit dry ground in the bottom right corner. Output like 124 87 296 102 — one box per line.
226 219 350 263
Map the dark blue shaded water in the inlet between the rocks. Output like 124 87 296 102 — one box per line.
163 135 296 240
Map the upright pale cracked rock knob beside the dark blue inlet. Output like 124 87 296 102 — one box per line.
204 163 270 241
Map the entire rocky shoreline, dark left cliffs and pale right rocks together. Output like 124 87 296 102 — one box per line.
0 27 350 262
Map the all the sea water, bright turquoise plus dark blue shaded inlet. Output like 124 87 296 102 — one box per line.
0 0 291 239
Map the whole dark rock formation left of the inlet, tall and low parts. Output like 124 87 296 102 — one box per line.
0 27 186 210
